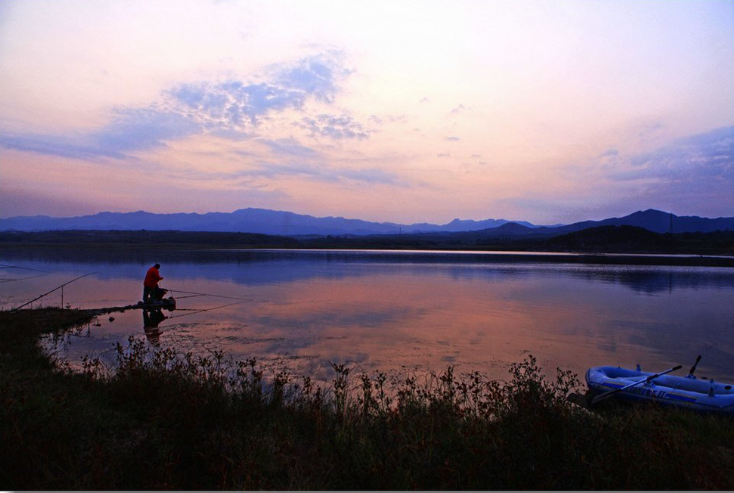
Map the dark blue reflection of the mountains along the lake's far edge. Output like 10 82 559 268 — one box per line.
3 249 734 293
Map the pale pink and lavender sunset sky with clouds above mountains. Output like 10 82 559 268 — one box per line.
0 0 734 224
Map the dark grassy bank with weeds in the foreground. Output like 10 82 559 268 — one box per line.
0 309 734 490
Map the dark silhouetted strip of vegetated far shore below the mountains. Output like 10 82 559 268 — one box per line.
0 227 734 266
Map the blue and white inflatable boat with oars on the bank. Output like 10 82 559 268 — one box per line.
586 365 734 415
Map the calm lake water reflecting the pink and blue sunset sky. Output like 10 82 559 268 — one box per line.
0 251 734 380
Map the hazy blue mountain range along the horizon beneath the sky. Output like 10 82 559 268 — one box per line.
0 208 734 237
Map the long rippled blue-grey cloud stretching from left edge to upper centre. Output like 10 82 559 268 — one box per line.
0 50 356 161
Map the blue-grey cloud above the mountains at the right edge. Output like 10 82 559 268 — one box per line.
548 127 734 220
